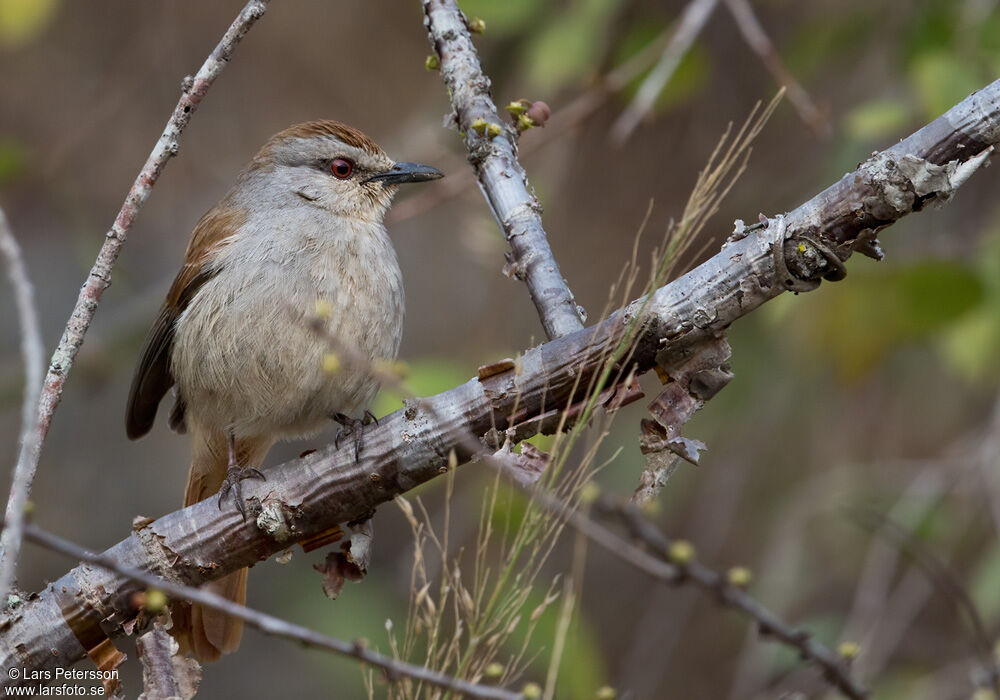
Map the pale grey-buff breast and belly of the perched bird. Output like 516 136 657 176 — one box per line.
172 209 404 437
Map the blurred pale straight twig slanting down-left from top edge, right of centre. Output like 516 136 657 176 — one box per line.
611 0 719 144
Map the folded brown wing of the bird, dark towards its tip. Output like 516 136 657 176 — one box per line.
125 205 246 440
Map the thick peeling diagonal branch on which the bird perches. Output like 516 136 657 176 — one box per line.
7 81 1000 677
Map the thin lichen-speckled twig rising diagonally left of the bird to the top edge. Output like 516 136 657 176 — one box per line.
6 0 270 558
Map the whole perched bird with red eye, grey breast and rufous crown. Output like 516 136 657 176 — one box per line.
125 120 443 661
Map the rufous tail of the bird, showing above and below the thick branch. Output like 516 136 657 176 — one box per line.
171 429 272 663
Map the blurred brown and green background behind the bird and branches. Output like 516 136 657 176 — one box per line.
0 0 1000 700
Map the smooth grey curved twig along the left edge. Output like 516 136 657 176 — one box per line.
0 209 45 605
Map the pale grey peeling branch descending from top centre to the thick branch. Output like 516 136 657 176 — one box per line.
423 0 583 339
